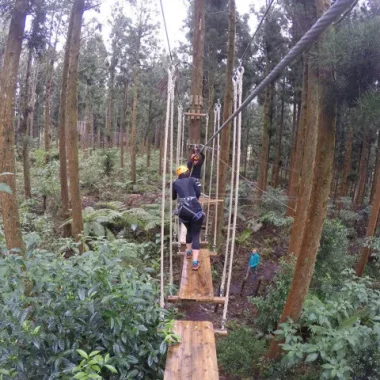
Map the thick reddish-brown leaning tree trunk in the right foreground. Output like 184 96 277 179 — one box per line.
268 0 336 359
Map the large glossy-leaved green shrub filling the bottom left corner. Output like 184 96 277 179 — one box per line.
0 243 170 379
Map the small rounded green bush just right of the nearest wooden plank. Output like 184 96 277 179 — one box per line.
217 327 266 377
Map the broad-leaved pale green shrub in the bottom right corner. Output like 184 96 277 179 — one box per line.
275 270 380 379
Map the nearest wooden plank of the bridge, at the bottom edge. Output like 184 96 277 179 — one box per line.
164 321 219 380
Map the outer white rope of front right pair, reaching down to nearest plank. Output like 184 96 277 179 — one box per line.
222 66 244 329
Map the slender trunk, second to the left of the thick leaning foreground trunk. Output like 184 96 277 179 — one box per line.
287 58 309 216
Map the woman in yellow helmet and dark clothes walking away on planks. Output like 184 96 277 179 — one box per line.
172 166 204 270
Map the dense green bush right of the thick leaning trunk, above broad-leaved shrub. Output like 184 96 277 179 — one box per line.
311 219 354 296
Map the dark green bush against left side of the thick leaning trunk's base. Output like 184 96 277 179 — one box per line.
251 259 294 332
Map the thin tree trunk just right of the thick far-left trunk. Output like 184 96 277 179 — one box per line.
20 47 33 199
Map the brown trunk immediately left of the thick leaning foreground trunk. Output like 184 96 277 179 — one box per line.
288 57 318 257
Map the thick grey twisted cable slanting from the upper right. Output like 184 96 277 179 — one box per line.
202 0 355 150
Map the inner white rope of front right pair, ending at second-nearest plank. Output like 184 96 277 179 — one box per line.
220 76 238 297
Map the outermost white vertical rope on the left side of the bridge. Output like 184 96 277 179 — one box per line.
160 66 175 308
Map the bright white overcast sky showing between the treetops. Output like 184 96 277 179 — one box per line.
89 0 265 50
